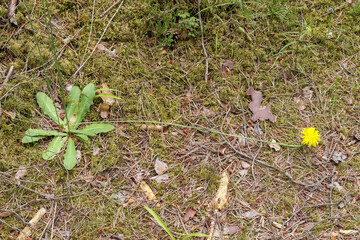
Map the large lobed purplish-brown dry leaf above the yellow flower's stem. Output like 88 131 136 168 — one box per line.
247 87 276 122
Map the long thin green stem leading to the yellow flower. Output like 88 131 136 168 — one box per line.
82 120 304 148
